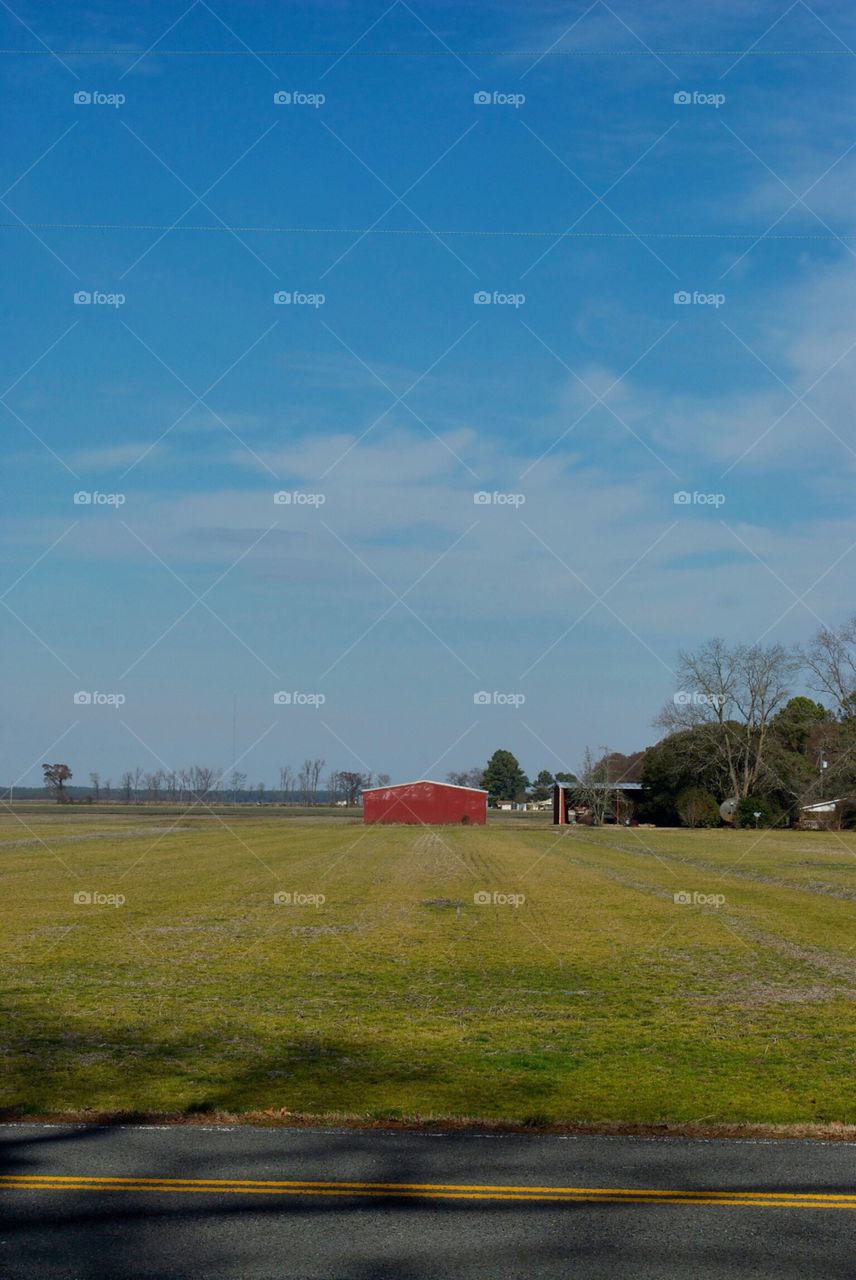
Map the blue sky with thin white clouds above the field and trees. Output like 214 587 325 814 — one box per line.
0 0 856 786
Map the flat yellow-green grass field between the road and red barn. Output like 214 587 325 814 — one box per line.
0 805 856 1124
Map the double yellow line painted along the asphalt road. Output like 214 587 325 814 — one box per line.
0 1174 856 1210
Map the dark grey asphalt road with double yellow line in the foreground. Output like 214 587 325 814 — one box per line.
0 1125 856 1280
